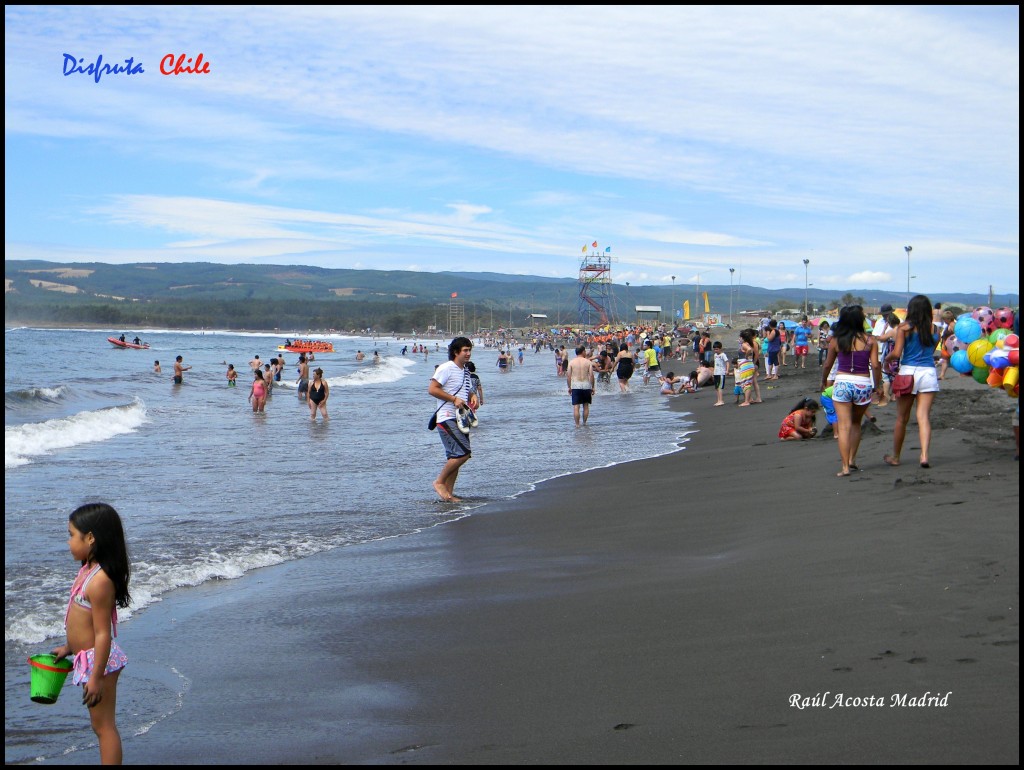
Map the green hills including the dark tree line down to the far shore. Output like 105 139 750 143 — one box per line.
4 260 1019 332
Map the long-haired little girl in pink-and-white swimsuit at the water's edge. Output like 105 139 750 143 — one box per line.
53 503 131 765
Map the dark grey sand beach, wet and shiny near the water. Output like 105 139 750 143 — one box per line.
41 367 1019 764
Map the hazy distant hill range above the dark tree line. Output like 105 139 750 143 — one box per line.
4 260 1020 325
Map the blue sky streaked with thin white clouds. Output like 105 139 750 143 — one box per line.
5 6 1020 293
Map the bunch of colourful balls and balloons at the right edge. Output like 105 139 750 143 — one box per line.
944 307 1020 398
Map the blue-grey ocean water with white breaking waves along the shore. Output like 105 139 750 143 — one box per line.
4 328 694 763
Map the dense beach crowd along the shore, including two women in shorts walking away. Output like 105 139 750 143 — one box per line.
428 295 1018 477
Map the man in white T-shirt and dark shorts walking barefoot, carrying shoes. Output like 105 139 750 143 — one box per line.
427 337 473 503
